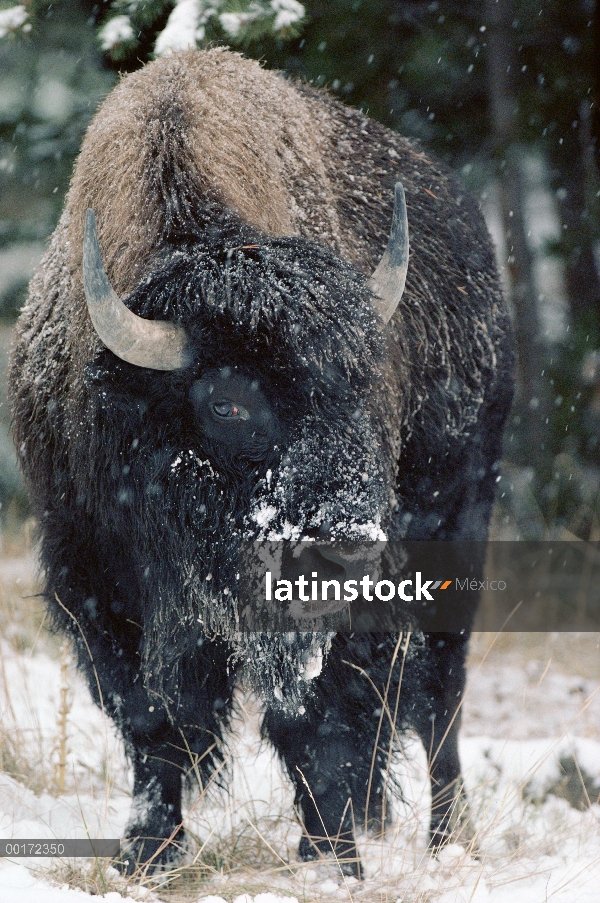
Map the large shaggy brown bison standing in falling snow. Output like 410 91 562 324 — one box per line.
10 49 512 875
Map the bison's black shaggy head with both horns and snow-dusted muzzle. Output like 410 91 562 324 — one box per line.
79 188 407 697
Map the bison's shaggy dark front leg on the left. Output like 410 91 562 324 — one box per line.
43 525 235 872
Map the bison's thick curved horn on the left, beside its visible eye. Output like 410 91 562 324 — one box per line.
83 210 191 370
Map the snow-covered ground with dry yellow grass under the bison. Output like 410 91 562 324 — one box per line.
0 559 600 903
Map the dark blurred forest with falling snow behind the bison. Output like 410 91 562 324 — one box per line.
0 0 600 539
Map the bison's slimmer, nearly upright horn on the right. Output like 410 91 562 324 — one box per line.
369 182 408 323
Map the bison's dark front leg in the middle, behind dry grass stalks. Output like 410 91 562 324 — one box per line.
263 635 393 877
